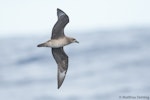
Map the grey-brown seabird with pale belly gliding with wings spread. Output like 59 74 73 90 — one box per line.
37 8 79 89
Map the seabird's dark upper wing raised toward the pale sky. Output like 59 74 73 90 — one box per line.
51 8 69 39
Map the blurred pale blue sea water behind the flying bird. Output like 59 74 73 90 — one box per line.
0 28 150 100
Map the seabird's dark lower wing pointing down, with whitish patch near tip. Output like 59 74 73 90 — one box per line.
52 47 68 89
